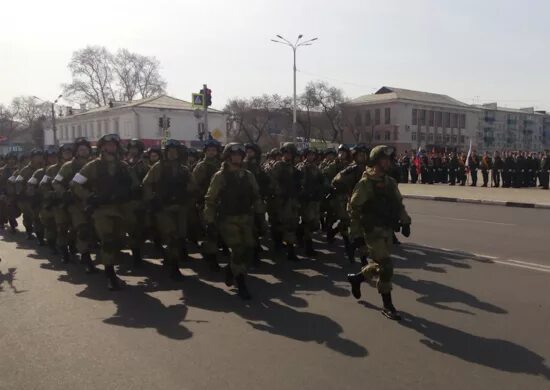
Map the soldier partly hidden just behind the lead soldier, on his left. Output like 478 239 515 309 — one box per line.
332 144 369 264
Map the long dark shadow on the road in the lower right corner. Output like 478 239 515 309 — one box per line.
400 314 550 380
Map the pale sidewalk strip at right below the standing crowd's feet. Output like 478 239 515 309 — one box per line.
399 183 550 209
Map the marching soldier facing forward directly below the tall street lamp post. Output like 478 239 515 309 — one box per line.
270 142 301 261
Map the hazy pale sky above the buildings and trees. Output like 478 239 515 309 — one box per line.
0 0 550 110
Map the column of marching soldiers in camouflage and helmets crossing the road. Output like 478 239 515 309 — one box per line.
0 139 414 319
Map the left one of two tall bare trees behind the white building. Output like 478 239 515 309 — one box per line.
63 46 115 106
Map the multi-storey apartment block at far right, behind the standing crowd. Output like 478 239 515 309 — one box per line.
476 103 547 152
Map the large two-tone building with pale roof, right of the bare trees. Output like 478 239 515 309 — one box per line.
343 87 479 152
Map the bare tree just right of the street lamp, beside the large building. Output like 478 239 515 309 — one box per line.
304 81 346 142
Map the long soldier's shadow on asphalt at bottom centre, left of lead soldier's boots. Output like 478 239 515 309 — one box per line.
182 278 368 357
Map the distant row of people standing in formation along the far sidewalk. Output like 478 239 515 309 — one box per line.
397 151 550 189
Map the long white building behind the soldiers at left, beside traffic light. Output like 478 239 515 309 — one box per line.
53 95 226 146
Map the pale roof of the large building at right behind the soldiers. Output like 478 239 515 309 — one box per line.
350 87 471 108
